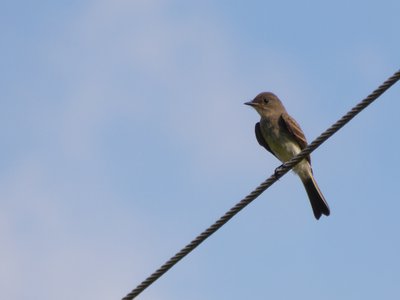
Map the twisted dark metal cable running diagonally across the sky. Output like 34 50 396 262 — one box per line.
122 70 400 300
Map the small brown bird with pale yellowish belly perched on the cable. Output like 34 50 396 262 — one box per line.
245 92 330 220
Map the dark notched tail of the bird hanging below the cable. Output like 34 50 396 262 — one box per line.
302 175 330 220
